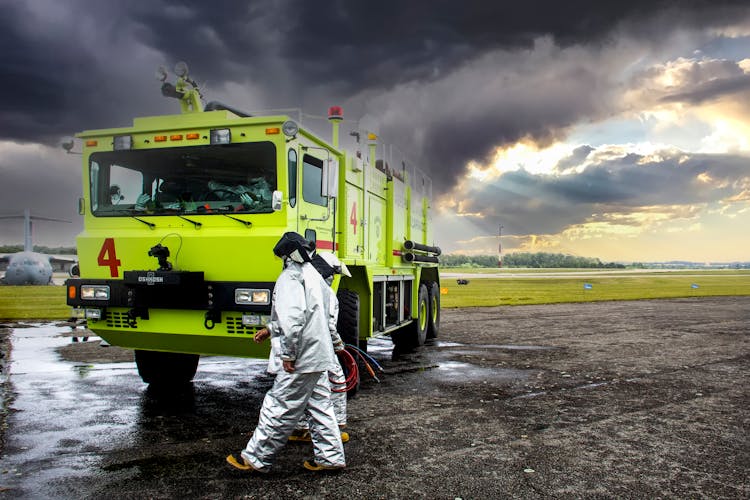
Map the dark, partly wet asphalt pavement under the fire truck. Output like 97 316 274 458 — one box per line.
0 297 750 499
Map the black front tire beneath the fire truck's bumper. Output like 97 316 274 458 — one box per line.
135 350 200 387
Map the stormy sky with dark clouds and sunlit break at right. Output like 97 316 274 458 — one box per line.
0 0 750 262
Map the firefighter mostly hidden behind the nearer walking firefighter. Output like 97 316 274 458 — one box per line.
290 252 352 443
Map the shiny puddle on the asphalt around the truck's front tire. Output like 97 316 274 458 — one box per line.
0 323 267 498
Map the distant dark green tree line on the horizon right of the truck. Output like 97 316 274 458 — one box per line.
440 252 625 269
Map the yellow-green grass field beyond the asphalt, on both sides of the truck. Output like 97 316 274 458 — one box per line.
0 269 750 320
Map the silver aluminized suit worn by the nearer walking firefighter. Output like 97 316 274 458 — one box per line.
241 260 346 470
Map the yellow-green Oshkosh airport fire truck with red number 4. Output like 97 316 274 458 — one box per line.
66 65 440 384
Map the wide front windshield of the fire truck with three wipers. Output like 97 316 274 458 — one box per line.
89 142 276 217
